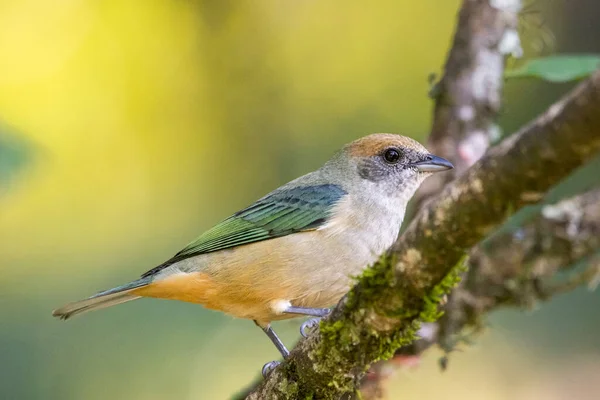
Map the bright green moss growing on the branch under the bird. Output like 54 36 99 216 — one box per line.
290 257 465 399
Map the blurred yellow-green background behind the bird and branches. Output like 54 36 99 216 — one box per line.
0 0 600 400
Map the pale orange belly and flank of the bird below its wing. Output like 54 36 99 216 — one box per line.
132 232 356 321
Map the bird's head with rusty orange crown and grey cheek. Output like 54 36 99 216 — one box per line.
331 133 453 201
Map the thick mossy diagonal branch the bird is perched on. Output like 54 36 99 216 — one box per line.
248 72 600 399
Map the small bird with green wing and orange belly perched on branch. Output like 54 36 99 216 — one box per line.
52 134 453 373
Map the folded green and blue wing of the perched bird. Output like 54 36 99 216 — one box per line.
142 184 346 277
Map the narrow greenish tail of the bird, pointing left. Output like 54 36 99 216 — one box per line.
52 277 152 319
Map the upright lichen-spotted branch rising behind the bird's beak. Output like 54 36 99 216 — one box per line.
415 0 521 204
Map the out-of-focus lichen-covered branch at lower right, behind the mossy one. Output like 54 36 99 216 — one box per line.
412 188 600 360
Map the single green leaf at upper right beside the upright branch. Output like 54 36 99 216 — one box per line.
504 54 600 82
